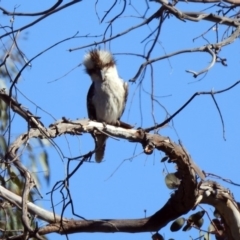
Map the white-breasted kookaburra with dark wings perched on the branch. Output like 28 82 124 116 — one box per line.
83 49 128 162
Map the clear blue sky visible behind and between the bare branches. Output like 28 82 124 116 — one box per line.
0 0 240 240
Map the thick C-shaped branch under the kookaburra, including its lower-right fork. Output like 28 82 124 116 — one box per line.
0 119 240 239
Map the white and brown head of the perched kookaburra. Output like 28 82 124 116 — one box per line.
83 49 118 82
